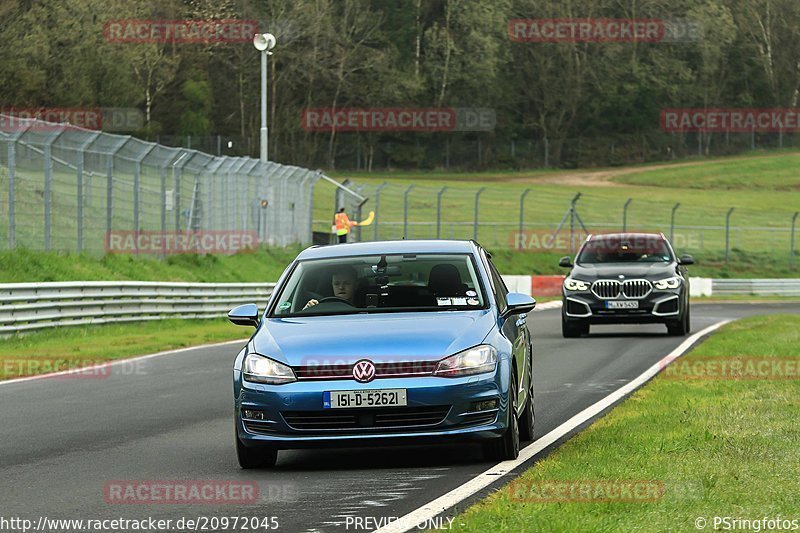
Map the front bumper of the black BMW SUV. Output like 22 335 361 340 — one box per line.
563 288 683 324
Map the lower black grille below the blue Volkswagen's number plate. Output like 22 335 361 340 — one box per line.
281 405 450 431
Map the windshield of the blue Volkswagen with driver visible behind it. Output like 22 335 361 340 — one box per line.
270 254 485 317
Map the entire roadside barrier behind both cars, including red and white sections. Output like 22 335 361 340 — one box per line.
0 276 800 335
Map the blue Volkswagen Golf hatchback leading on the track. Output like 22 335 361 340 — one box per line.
228 241 536 468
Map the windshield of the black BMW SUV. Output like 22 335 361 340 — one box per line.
577 235 672 264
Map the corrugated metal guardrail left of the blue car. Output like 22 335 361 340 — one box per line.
0 281 275 334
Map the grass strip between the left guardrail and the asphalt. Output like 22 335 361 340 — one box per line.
0 318 252 380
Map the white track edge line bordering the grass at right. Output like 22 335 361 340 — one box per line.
374 320 731 533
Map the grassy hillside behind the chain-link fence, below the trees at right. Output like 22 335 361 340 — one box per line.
313 152 800 255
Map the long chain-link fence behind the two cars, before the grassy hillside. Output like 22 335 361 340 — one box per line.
314 179 800 262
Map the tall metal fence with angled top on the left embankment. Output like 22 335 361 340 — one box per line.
0 115 336 253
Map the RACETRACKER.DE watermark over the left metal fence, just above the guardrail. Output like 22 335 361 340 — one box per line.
105 230 259 254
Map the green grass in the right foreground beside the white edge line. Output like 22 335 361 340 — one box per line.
454 315 800 531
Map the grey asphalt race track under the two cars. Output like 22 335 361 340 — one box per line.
0 303 800 532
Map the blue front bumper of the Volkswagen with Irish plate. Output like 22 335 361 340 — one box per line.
235 368 509 449
